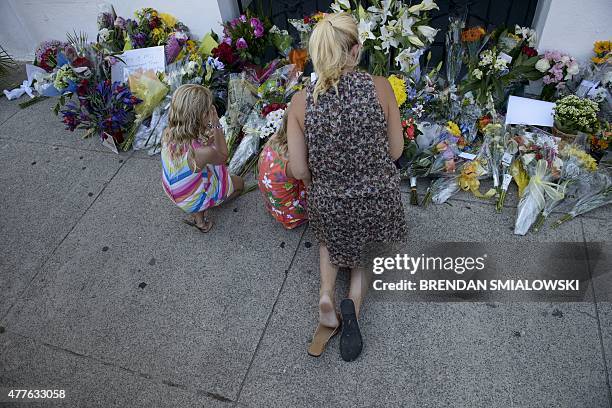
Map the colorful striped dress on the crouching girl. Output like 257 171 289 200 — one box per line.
161 142 234 213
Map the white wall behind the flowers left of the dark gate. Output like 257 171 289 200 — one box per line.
0 0 238 60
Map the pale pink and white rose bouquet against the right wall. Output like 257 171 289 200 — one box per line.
535 51 580 101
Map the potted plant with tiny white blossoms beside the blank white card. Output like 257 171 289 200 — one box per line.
554 95 599 133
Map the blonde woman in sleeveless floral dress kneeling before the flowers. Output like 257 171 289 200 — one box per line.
287 13 407 361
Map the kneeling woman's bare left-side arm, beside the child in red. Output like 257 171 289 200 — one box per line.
287 91 311 185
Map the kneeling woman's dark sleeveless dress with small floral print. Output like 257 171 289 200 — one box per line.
304 72 407 267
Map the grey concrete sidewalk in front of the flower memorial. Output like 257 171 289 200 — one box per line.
0 68 612 408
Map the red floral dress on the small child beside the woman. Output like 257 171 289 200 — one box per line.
257 144 308 229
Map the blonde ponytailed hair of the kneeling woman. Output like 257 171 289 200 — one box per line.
308 13 359 103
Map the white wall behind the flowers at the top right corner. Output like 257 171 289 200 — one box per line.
534 0 612 62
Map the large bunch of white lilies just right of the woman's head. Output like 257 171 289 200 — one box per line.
331 0 438 77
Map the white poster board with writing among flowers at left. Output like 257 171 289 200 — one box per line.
111 45 166 82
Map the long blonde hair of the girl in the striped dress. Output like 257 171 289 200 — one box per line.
163 84 213 158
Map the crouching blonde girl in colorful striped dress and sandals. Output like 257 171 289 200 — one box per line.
161 84 244 232
